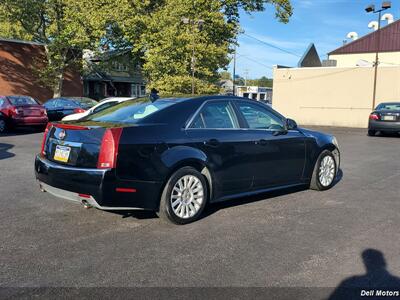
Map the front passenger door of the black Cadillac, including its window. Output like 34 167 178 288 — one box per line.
235 101 305 189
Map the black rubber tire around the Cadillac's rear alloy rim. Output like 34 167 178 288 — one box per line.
158 167 208 225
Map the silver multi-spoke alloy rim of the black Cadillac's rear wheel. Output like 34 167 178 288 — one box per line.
170 175 204 219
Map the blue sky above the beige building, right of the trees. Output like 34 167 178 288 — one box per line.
228 0 400 79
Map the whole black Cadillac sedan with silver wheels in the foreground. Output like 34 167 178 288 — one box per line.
35 96 340 224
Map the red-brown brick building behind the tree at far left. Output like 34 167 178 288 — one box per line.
0 38 83 102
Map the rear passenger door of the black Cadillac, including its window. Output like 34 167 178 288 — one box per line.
186 100 252 198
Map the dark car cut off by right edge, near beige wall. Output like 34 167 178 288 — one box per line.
368 102 400 136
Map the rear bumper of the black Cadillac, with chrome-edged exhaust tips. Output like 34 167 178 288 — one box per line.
35 155 162 210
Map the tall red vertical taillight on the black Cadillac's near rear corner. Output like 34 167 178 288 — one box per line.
97 128 122 169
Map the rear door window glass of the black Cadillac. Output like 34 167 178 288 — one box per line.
190 101 239 129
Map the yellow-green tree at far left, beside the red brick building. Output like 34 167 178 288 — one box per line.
0 0 123 96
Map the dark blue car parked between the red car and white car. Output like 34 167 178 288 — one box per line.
44 97 97 121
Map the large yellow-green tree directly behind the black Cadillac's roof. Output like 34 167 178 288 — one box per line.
121 0 292 94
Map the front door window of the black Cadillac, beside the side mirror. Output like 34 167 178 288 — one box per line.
238 102 285 130
